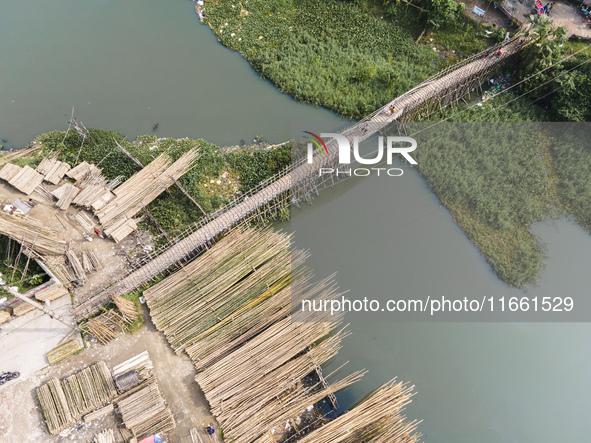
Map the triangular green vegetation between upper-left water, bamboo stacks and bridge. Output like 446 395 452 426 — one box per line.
32 129 291 232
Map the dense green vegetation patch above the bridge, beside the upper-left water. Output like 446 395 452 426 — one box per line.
204 0 494 118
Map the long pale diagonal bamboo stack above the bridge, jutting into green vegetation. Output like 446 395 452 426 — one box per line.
96 149 198 237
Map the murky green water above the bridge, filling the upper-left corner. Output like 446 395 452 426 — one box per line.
0 0 343 147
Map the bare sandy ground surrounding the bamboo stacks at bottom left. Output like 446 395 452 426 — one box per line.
0 310 221 443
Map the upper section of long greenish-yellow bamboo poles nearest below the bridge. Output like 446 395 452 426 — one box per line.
144 229 305 353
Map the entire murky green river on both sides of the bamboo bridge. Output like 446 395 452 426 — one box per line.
0 0 591 443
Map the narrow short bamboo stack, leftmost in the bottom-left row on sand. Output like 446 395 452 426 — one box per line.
37 378 75 435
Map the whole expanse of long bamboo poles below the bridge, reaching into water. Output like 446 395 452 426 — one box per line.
144 229 418 443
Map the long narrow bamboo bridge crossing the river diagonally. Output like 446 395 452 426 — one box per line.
74 35 529 319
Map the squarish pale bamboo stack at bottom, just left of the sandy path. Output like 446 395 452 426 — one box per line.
117 382 175 440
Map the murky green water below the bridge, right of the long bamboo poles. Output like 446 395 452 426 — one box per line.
285 168 591 443
